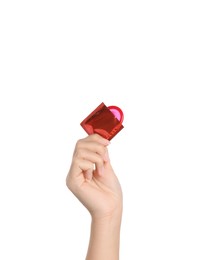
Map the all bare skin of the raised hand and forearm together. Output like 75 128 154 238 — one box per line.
66 134 122 260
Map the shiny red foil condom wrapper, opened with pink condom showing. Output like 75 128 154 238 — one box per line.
80 102 124 140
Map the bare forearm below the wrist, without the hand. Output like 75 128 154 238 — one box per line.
86 211 122 260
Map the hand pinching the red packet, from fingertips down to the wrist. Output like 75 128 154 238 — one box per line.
66 134 122 219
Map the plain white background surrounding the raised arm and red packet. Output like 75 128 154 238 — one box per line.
0 0 211 260
